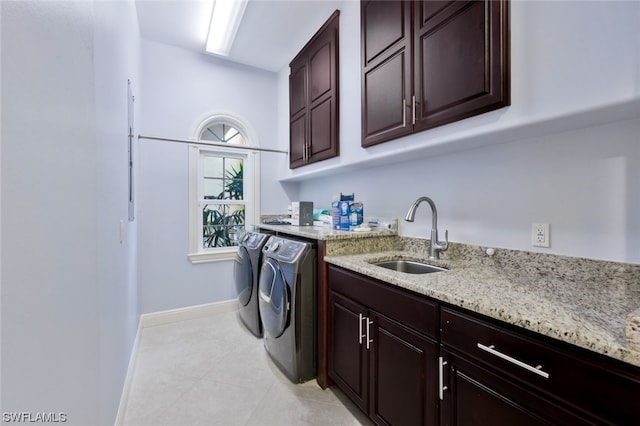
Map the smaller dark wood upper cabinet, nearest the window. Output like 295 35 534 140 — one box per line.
289 10 340 169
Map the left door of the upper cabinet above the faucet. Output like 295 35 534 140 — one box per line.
360 0 413 147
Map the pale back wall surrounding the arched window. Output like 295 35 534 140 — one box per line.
139 41 286 313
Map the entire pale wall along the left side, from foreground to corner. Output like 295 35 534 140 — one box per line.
1 2 138 425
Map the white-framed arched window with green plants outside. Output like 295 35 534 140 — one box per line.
189 115 259 263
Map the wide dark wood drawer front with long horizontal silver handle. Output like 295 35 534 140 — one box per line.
440 307 640 425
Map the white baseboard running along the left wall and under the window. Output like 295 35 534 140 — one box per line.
115 299 238 426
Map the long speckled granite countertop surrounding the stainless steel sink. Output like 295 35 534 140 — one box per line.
325 243 640 366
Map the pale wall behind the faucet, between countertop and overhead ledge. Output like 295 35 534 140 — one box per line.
300 120 640 263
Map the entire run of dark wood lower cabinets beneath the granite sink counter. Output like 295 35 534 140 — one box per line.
327 265 640 426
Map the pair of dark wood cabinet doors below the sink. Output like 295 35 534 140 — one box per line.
329 269 438 425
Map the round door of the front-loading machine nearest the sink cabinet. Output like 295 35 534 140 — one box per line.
258 258 291 337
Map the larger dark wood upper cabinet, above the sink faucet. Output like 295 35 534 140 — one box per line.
361 0 510 147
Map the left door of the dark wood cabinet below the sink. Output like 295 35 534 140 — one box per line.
329 292 368 413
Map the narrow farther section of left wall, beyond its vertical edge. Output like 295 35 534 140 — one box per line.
94 1 144 424
